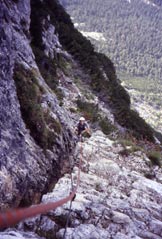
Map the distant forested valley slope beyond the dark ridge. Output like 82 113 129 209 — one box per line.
61 0 162 133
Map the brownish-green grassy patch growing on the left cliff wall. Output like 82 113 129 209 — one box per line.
14 65 61 150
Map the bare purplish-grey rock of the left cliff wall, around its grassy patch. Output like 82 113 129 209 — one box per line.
0 0 72 208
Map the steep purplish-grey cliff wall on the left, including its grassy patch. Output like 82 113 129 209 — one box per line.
0 1 72 208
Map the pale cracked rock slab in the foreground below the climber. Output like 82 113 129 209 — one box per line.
5 131 162 239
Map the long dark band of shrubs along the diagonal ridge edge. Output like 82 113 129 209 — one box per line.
31 0 154 141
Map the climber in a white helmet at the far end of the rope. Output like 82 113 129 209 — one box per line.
75 117 91 137
